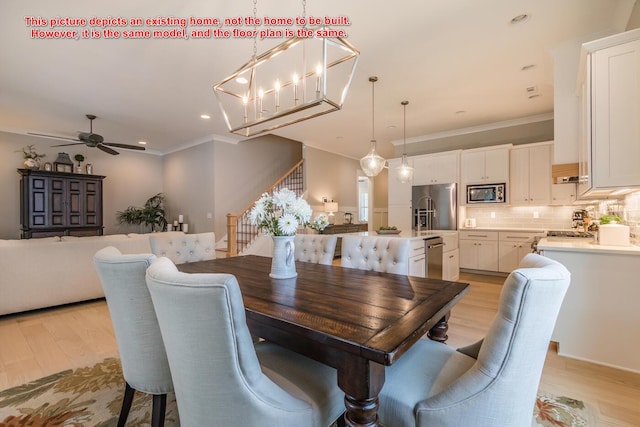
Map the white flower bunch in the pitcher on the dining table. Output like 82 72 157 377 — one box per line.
249 188 311 236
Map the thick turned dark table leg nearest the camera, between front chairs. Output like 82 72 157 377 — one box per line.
338 357 384 427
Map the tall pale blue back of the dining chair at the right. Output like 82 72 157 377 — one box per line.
416 254 571 426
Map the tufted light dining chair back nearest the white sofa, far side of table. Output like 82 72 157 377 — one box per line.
149 232 216 264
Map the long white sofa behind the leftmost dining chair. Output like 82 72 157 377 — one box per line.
0 232 182 315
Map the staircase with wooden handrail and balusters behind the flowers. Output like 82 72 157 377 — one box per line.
227 160 304 257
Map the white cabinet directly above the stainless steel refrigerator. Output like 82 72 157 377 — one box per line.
411 151 459 185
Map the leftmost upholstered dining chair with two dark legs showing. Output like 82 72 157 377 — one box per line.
93 246 173 427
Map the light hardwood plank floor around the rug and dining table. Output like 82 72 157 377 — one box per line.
0 273 640 427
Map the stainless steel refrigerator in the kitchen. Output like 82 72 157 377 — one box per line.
411 184 458 231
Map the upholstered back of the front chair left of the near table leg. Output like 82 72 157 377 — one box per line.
147 258 316 427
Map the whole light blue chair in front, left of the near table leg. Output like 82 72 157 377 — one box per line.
147 257 344 427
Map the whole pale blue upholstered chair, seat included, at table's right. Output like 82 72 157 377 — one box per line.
378 254 571 427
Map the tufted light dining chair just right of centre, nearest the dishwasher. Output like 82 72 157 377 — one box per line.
340 236 411 275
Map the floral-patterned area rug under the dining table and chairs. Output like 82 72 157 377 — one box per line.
0 358 598 427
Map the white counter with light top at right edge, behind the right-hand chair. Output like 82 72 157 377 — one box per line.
538 238 640 372
